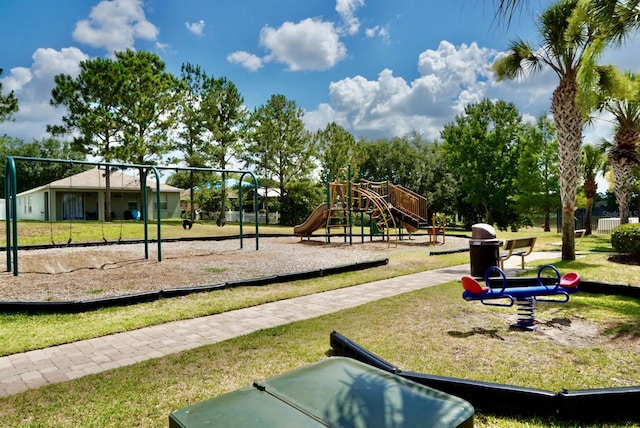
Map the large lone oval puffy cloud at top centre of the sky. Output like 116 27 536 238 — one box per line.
260 18 347 71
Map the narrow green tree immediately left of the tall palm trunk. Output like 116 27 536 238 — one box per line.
516 115 560 232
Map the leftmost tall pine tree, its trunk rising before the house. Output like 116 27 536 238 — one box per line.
47 58 126 221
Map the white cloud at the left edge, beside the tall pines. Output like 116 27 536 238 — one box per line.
2 47 89 142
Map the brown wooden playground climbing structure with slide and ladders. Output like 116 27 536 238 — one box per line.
294 171 428 244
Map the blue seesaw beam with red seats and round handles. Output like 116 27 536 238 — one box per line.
462 265 580 306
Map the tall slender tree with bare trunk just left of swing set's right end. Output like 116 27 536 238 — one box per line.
201 77 249 226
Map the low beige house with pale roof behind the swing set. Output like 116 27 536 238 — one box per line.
16 168 180 221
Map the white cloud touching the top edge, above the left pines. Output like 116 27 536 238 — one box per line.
73 0 158 54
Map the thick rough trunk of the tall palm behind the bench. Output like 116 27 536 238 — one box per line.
551 73 584 260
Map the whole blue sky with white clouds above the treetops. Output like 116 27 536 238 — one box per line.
0 0 640 150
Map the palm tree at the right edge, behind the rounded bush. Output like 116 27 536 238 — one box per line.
594 66 640 224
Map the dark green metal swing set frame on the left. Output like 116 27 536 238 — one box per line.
4 156 259 276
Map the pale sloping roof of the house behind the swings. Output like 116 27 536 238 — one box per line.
22 168 180 193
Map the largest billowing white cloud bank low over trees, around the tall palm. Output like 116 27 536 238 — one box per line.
305 35 637 149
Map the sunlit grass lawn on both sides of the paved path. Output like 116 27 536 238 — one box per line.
0 226 640 427
